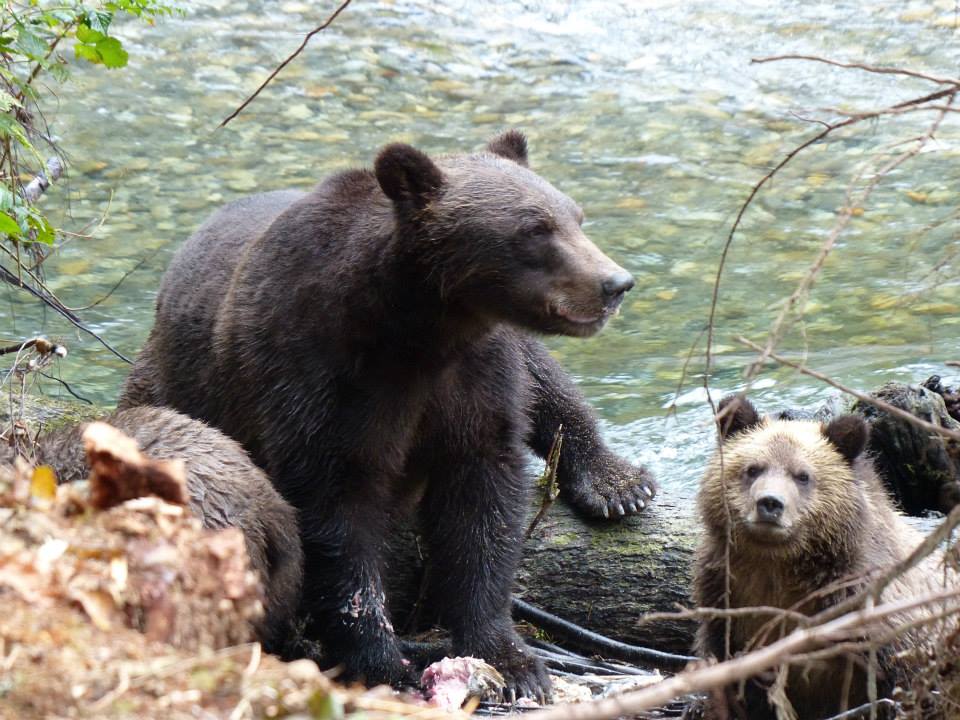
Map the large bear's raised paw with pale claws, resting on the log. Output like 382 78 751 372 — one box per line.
560 453 657 518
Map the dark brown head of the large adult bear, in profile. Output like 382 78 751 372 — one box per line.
374 131 633 336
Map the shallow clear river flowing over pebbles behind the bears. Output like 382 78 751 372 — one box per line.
0 0 960 487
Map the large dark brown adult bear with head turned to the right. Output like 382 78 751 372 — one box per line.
120 131 654 696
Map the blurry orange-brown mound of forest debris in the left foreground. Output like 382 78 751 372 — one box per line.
0 444 464 720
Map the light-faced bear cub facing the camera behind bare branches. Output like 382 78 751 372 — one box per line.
693 396 956 720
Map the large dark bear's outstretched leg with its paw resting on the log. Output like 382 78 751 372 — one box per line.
522 338 657 517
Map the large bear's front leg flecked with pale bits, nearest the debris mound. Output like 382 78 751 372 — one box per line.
300 498 417 686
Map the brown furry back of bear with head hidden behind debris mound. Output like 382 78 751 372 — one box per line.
19 407 303 655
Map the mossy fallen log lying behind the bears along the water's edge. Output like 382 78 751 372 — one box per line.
9 384 960 654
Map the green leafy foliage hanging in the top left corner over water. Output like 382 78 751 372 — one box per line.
0 0 180 268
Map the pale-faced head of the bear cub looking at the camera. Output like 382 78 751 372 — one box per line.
699 395 869 558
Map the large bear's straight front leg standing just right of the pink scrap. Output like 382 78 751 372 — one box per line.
421 452 550 700
